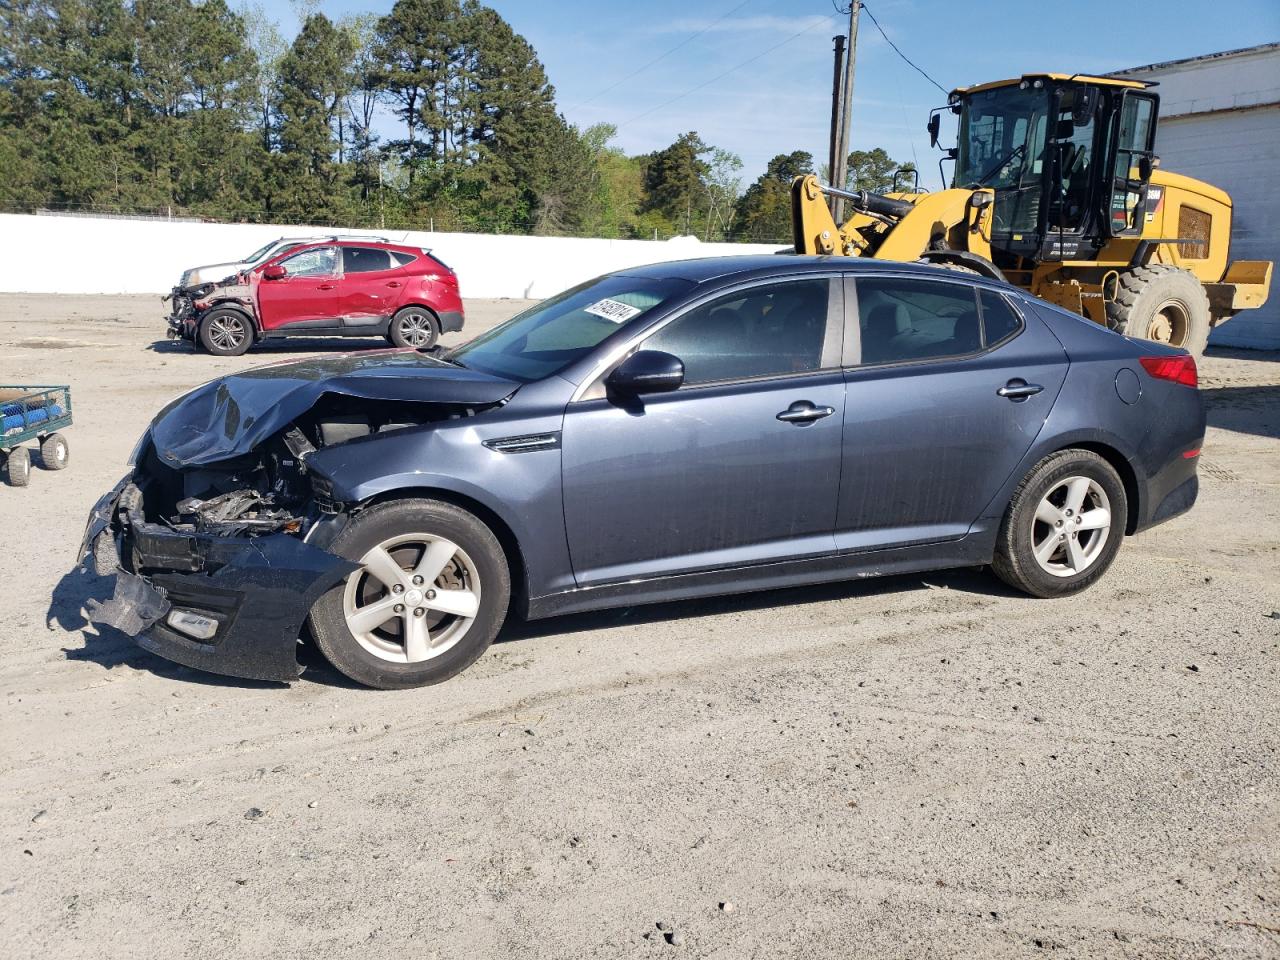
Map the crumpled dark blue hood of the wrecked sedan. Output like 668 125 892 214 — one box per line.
151 349 520 468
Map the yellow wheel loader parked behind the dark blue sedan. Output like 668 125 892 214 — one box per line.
791 73 1271 353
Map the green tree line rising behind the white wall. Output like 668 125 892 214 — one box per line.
0 0 921 241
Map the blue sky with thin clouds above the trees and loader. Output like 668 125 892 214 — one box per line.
264 0 1280 187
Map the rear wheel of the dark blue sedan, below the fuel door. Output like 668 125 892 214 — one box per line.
992 449 1129 598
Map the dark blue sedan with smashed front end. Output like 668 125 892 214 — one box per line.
83 256 1204 687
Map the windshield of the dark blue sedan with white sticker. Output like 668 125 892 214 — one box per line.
449 274 692 383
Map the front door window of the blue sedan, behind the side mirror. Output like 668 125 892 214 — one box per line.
643 279 831 385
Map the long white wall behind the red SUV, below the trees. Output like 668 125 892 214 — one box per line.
0 214 780 298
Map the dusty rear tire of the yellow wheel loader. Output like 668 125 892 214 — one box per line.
1107 264 1210 356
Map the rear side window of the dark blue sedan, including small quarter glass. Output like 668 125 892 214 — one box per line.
858 276 1003 364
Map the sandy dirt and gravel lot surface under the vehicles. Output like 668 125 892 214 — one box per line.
0 296 1280 960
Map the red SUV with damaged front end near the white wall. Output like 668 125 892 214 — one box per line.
169 239 463 357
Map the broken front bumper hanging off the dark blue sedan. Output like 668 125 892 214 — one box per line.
81 477 357 682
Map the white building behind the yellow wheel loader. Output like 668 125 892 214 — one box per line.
1114 44 1280 349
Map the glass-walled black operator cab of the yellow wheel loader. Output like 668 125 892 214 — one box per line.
950 74 1158 268
